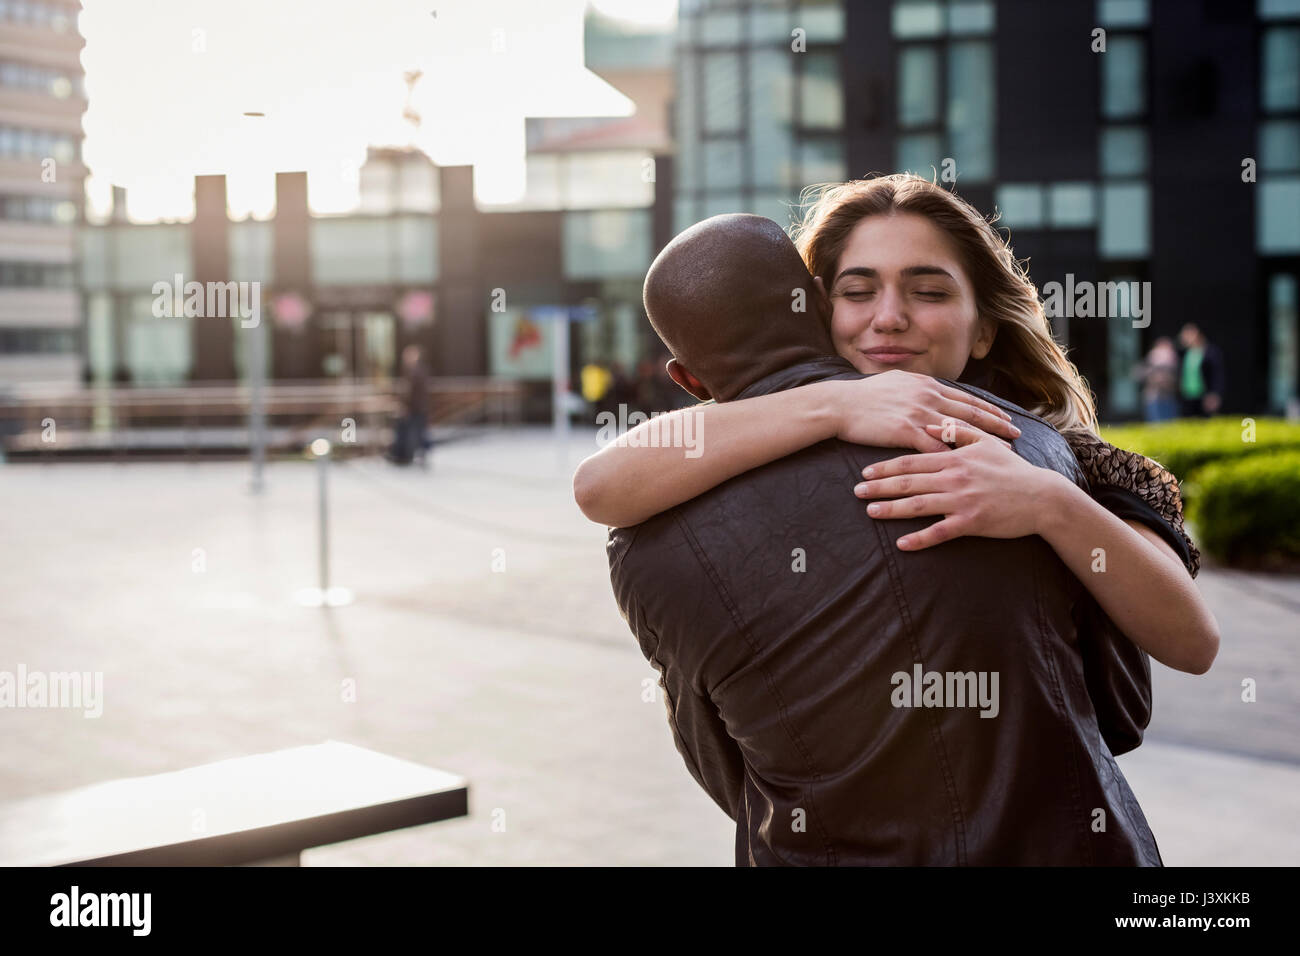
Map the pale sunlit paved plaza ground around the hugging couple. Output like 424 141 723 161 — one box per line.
0 428 1300 866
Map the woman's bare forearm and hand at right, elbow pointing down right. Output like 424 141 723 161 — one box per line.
855 427 1219 674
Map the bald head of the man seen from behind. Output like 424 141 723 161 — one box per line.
645 213 835 402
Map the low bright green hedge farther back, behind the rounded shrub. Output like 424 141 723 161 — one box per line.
1101 418 1300 481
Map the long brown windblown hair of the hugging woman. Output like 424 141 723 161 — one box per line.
792 173 1097 433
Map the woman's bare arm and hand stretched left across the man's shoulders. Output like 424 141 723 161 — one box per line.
573 369 1019 528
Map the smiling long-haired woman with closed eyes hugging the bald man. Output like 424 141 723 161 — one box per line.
573 174 1219 674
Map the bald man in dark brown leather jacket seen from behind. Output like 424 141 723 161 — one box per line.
608 216 1161 865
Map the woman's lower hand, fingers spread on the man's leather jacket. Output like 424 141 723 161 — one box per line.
853 421 1066 551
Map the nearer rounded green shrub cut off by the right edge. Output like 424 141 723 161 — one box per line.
1187 450 1300 564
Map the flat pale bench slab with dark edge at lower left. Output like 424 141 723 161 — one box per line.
0 740 469 866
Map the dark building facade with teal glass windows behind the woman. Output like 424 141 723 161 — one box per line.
675 0 1300 420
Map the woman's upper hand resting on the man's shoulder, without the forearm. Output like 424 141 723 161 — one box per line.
827 368 1021 451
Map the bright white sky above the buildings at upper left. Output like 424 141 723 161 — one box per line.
81 0 676 221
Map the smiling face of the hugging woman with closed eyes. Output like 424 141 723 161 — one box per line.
827 213 993 380
